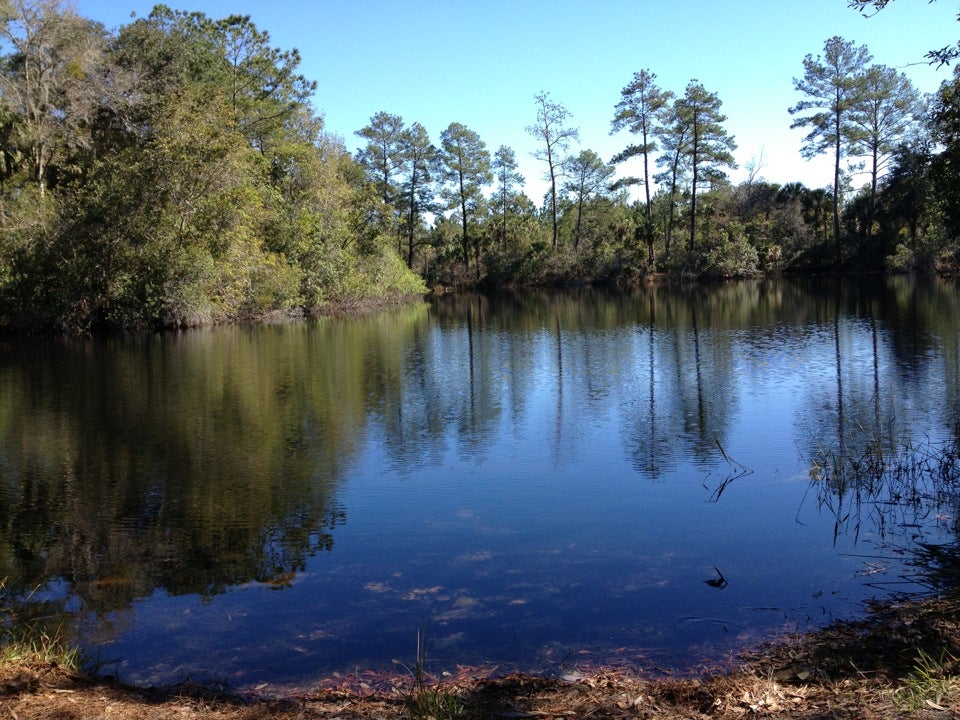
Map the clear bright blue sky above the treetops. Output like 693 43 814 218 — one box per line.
75 0 960 203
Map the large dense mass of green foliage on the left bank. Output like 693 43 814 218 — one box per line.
0 0 425 332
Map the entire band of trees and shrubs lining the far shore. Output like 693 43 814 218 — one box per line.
0 0 960 333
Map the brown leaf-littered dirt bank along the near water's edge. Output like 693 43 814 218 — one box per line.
0 597 960 720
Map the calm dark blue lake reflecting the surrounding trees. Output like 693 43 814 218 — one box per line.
0 278 960 689
